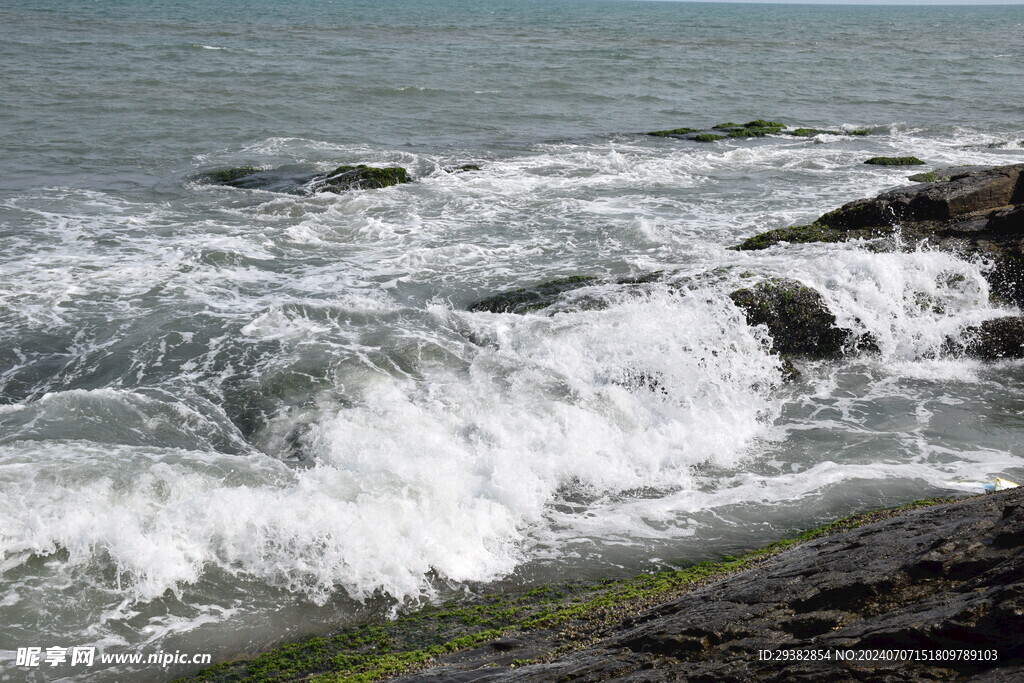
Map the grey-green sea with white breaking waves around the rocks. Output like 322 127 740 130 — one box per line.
0 0 1024 681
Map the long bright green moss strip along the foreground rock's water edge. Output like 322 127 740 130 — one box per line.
180 500 951 683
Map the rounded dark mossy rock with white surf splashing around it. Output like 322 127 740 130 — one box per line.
729 279 852 358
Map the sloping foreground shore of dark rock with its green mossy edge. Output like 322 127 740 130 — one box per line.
186 488 1024 683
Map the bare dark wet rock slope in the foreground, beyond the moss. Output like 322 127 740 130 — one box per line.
397 488 1024 682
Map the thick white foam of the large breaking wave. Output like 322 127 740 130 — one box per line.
0 286 778 601
